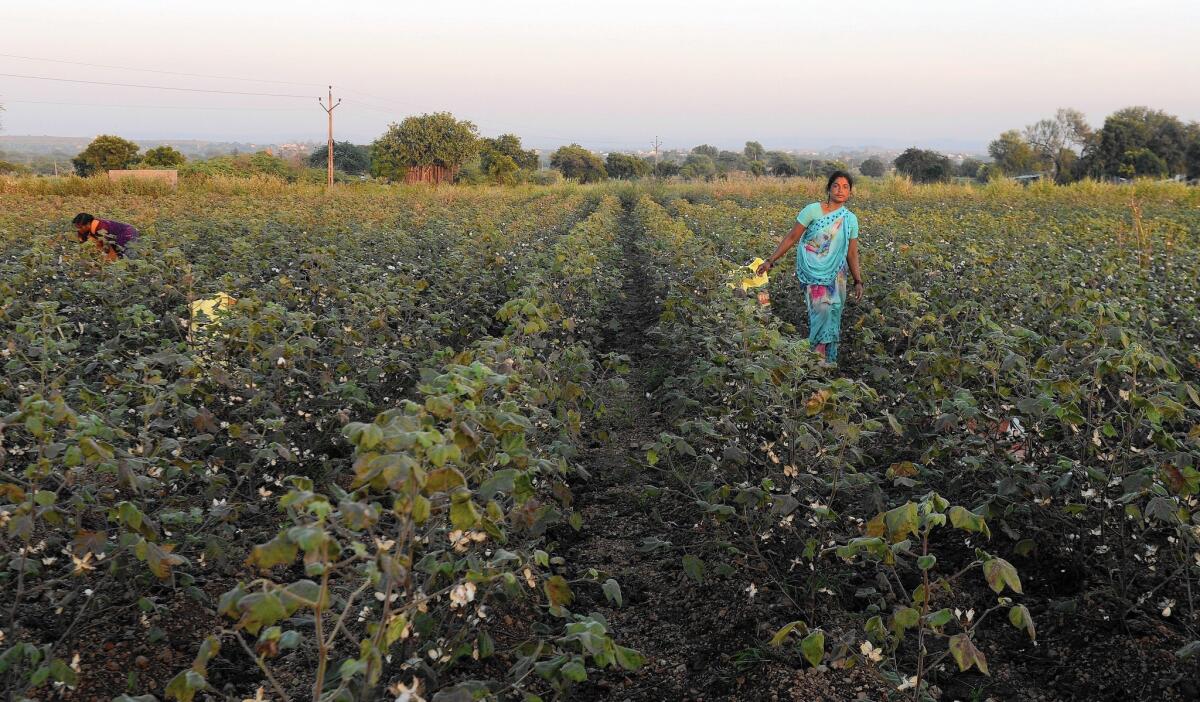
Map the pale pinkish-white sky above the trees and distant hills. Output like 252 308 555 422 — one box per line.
0 0 1200 150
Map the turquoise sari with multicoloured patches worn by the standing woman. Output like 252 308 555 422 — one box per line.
796 203 858 364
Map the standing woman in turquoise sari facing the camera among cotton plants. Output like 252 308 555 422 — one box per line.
757 170 863 364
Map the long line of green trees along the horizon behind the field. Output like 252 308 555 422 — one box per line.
21 107 1200 185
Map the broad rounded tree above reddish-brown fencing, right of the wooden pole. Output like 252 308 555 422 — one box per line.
369 112 479 180
